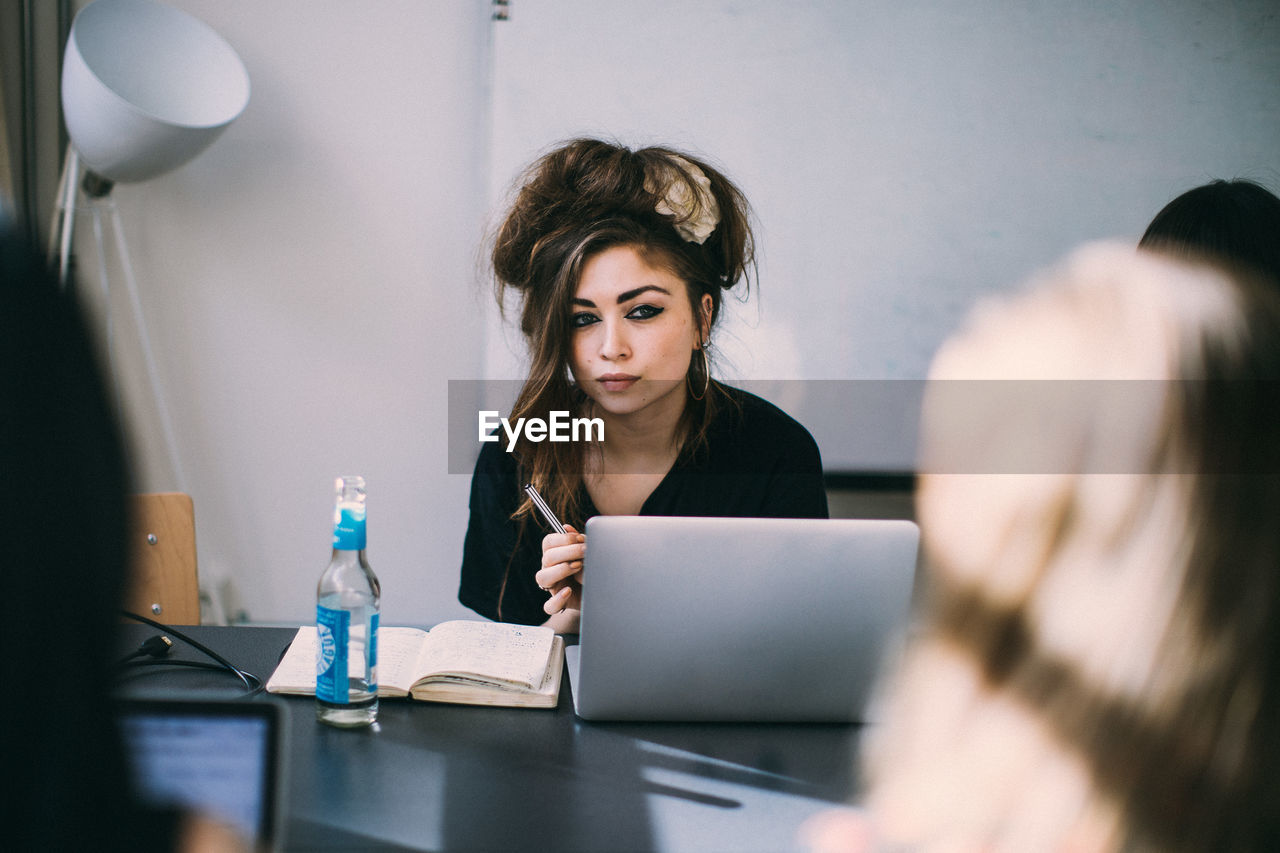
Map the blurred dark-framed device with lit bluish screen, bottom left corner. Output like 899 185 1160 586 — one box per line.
120 698 285 850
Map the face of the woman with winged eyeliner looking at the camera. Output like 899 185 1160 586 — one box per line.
570 246 712 415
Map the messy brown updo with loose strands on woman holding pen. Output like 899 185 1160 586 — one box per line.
493 138 754 524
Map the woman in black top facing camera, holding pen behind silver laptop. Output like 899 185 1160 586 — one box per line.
458 140 827 631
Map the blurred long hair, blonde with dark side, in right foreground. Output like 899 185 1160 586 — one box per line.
868 246 1280 852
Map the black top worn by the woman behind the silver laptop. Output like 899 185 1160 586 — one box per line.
458 386 827 625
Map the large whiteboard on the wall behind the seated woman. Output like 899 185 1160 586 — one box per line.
485 0 1280 473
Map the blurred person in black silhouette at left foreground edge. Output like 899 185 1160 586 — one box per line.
0 228 247 852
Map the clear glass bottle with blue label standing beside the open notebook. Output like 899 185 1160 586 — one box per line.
316 476 381 727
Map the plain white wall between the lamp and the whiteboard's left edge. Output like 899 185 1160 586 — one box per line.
81 0 489 624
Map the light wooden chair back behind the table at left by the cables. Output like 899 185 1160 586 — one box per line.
124 492 200 625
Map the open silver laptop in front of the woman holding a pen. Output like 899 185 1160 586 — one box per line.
566 516 919 722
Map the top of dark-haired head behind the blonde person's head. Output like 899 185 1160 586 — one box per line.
1138 179 1280 287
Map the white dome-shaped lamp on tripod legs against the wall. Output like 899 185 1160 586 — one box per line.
49 0 250 491
